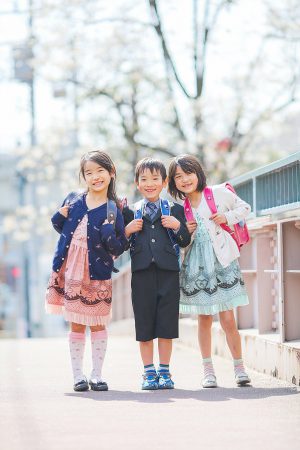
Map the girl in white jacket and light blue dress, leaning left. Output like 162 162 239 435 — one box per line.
169 155 251 388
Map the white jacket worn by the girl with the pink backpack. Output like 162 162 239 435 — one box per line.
193 185 251 267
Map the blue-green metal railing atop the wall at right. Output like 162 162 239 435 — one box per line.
231 152 300 216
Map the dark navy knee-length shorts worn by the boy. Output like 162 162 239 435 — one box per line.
131 263 180 342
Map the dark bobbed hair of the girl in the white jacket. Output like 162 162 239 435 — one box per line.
168 154 206 200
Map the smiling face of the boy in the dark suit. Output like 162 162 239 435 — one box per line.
136 169 167 202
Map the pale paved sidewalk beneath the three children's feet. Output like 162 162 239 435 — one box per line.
0 331 300 450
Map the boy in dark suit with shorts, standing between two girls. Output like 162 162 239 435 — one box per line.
123 158 191 390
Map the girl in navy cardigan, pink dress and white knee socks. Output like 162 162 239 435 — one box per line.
46 151 127 391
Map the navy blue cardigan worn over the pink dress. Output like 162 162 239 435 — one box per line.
51 193 128 280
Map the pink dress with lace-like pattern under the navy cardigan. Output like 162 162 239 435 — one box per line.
46 215 112 326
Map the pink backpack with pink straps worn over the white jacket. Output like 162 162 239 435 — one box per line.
183 183 250 249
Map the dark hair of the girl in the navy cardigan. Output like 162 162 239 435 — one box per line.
79 150 120 207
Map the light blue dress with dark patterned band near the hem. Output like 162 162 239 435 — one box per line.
180 216 249 315
